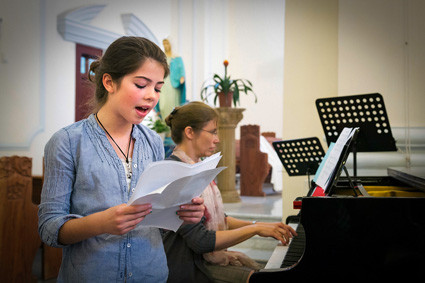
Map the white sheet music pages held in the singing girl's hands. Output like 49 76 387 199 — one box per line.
127 153 225 231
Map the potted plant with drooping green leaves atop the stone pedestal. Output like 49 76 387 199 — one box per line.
201 60 257 107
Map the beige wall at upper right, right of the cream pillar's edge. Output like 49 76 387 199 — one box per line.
338 0 425 127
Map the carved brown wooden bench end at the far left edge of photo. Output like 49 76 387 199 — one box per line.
0 156 41 282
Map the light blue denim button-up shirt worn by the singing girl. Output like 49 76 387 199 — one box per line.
38 115 168 282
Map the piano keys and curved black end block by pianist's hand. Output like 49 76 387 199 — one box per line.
264 223 305 269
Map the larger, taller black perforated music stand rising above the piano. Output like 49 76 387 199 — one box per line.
316 93 397 178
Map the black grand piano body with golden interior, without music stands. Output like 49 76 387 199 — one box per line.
250 169 425 282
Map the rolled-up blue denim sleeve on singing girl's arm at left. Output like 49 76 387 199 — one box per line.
38 130 81 247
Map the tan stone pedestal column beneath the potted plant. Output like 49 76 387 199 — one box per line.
216 107 245 202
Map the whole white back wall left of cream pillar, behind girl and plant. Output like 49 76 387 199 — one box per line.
0 0 284 175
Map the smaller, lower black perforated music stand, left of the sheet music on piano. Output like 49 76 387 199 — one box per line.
272 137 325 193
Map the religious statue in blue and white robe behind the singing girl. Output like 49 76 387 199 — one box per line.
155 38 186 119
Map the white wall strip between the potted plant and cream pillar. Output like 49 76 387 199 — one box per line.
227 0 285 138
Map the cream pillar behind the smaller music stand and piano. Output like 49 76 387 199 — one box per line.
282 0 338 218
